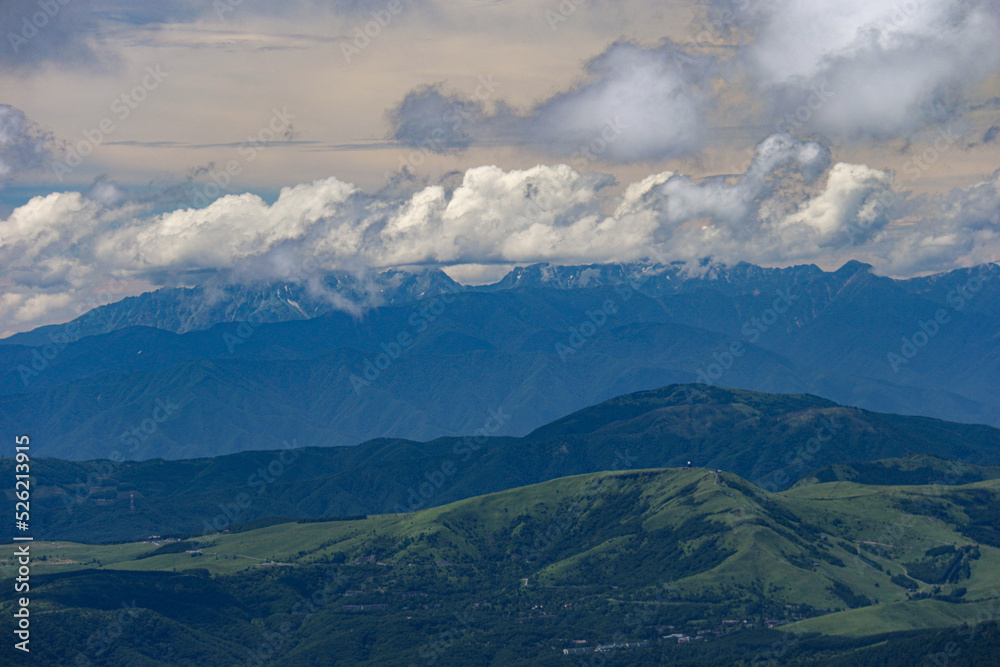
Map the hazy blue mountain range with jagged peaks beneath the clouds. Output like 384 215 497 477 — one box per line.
0 262 1000 459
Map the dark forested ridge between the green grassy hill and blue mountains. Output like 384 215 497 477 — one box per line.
7 385 1000 542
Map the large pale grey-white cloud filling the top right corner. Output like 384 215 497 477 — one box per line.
715 0 1000 138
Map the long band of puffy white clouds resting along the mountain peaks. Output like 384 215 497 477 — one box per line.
0 134 1000 331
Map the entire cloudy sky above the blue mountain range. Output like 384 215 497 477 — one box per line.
0 0 1000 335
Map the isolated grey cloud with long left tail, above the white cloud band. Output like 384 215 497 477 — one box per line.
389 42 714 167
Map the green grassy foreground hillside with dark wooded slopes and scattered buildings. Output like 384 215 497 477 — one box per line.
0 468 1000 665
